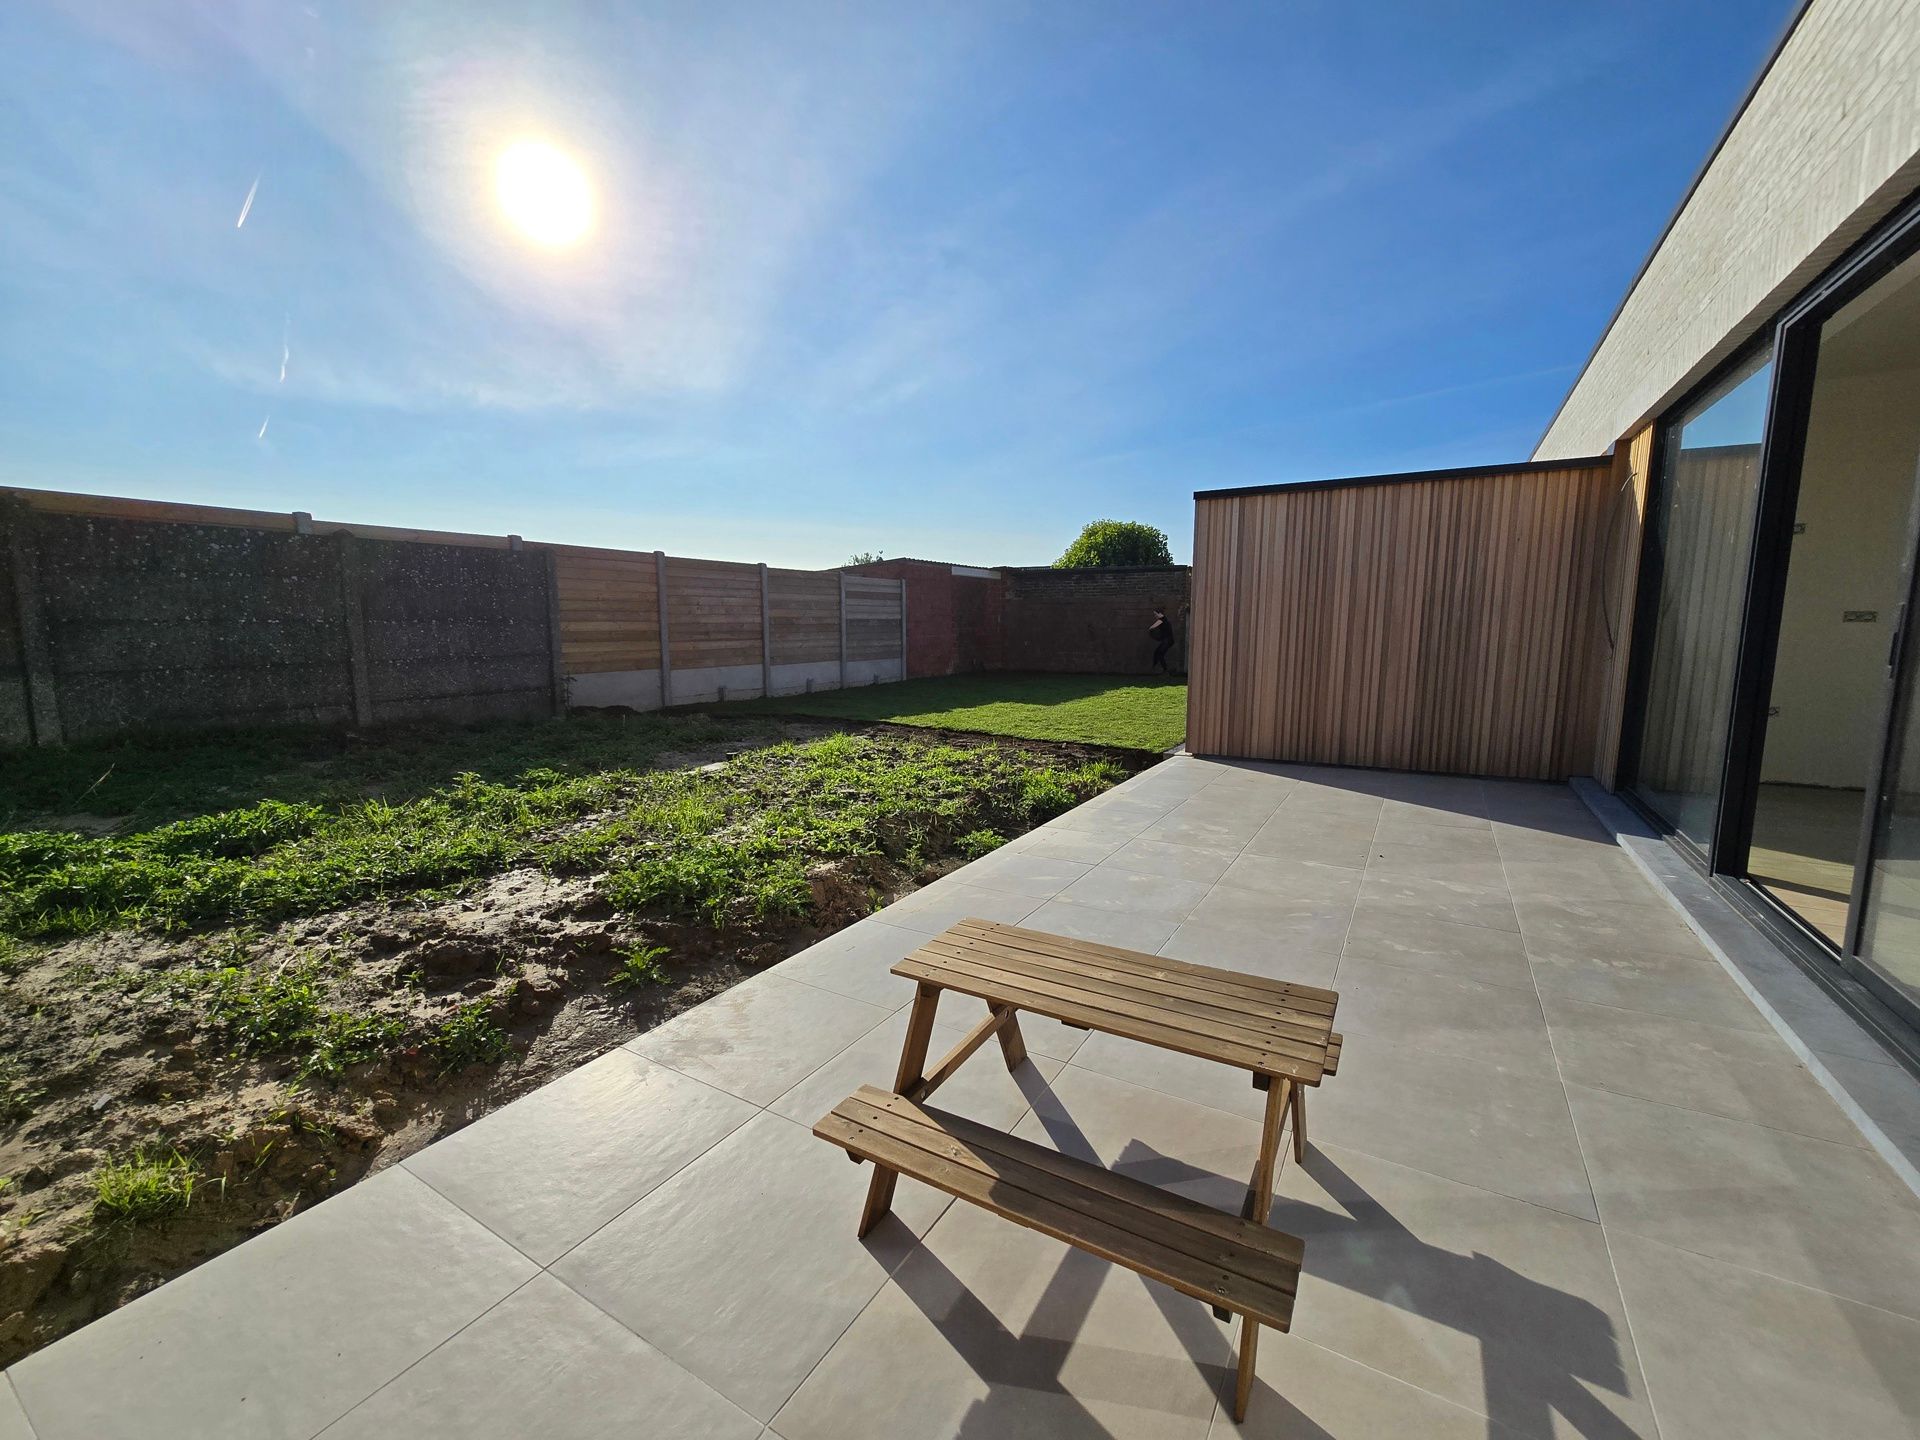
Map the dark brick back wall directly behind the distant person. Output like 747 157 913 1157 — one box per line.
1002 564 1188 676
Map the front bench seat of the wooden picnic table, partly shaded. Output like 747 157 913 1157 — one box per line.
814 1085 1304 1331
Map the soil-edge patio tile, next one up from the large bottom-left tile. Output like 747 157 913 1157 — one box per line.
401 1050 755 1265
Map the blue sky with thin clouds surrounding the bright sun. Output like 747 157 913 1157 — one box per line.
0 0 1789 564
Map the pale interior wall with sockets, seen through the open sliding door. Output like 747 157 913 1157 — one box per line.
1761 362 1920 787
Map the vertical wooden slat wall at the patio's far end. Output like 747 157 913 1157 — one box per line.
1187 463 1615 780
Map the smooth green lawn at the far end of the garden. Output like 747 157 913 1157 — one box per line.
720 674 1187 751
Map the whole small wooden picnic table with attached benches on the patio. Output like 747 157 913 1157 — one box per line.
814 920 1340 1419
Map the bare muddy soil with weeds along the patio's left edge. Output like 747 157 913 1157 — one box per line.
0 726 1142 1365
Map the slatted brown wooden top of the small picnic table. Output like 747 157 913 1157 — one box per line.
893 920 1340 1085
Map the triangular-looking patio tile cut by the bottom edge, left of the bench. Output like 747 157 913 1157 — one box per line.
321 1275 760 1440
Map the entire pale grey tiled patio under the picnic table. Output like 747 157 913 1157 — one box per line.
0 756 1920 1440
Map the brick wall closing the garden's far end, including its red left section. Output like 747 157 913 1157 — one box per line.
849 561 1188 678
